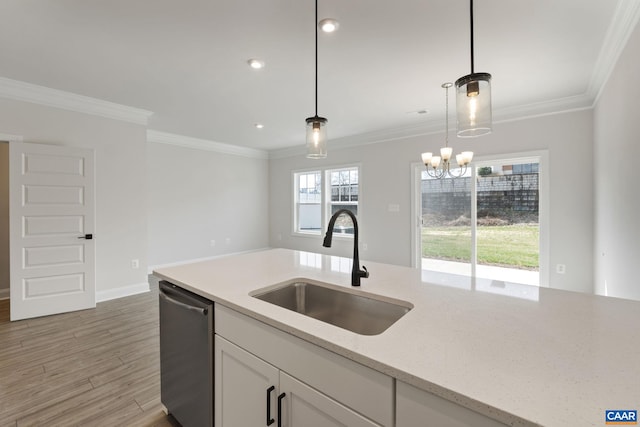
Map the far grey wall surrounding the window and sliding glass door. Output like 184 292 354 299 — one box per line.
269 110 593 292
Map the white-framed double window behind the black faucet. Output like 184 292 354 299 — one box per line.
294 166 360 236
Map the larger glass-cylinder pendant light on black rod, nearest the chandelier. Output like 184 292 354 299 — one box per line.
456 0 491 138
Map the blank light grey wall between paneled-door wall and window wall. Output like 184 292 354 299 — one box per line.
147 142 269 267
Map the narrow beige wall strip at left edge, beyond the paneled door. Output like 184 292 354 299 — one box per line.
0 141 10 298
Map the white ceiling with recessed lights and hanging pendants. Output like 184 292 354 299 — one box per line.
0 0 640 150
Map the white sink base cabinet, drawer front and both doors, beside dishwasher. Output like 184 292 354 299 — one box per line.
214 306 394 427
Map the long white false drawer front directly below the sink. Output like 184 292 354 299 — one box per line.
214 306 394 426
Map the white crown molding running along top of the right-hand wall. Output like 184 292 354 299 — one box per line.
587 0 640 105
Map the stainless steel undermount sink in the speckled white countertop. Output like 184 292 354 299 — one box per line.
250 280 413 335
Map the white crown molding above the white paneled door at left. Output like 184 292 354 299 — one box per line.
0 77 153 126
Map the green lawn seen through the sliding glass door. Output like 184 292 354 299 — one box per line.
422 224 539 270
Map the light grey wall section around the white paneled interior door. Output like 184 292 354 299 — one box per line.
0 99 147 298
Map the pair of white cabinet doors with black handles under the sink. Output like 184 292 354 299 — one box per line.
215 336 379 427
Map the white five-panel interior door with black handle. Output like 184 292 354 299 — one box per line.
9 142 96 320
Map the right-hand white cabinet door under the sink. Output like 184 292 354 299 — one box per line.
280 371 380 427
